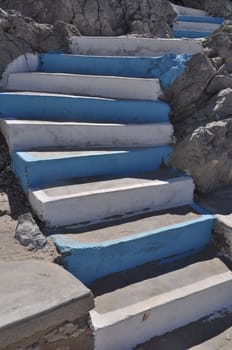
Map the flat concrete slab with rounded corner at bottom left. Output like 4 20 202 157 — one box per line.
0 261 93 349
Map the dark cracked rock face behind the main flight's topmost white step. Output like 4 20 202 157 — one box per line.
0 0 176 37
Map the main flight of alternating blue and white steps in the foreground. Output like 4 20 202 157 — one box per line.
0 10 232 350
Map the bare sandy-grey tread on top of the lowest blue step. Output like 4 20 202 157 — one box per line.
53 206 201 246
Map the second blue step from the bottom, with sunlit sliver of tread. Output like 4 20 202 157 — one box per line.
12 146 171 191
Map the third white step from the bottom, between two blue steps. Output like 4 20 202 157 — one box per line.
0 120 173 151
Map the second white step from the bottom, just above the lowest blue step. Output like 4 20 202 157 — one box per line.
28 169 194 227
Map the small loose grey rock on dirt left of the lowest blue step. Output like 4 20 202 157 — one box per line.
15 213 47 249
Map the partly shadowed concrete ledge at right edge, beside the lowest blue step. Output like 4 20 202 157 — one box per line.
198 186 232 259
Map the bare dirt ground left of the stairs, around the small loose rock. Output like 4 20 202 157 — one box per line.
0 134 59 261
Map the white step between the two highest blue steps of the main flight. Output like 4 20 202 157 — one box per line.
6 72 162 100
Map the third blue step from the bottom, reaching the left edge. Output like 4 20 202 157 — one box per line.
0 92 170 123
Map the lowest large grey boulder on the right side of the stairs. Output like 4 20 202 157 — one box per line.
170 119 232 192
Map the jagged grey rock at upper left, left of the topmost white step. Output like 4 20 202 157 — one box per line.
0 9 79 77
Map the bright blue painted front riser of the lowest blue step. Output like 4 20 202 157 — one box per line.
52 208 213 286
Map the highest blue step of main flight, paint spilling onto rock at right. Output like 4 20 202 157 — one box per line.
39 53 191 90
